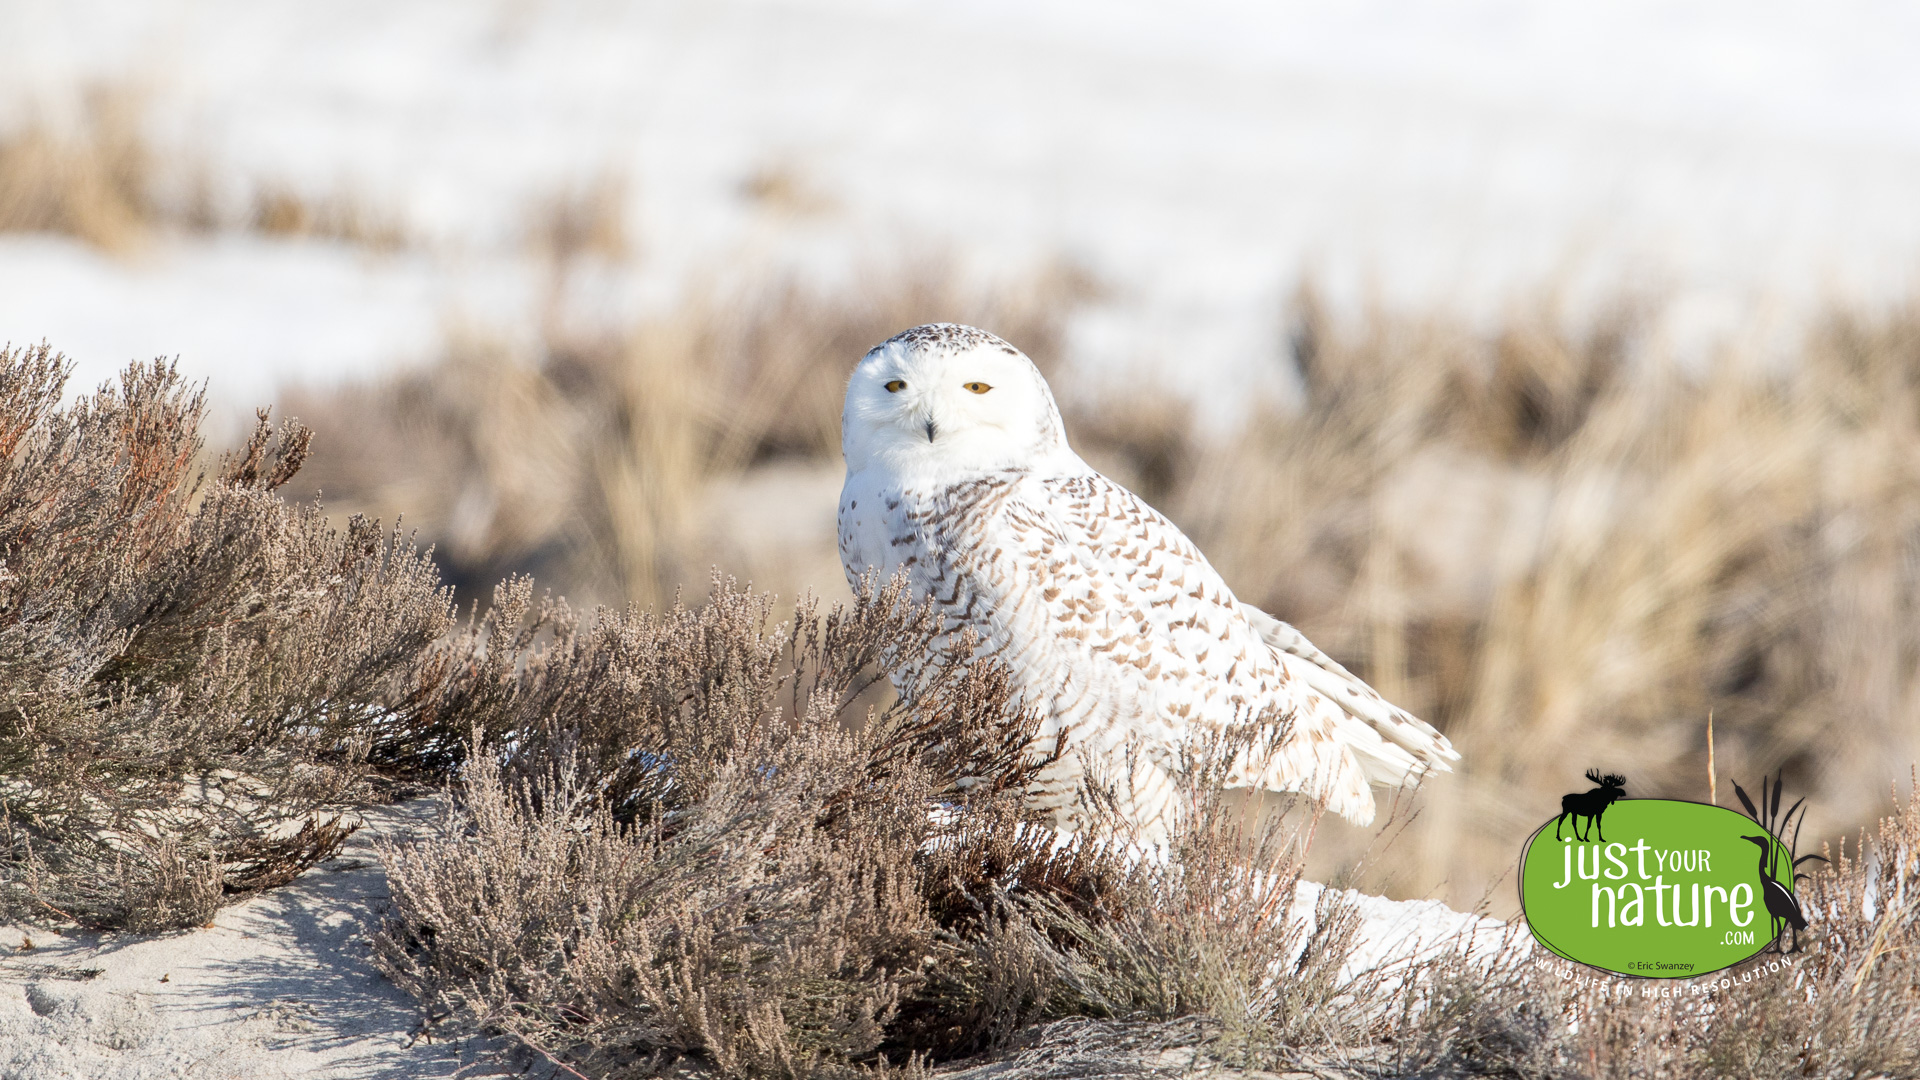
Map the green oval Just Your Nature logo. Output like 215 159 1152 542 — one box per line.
1521 798 1805 978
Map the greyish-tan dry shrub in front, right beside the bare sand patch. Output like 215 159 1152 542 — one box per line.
378 730 931 1076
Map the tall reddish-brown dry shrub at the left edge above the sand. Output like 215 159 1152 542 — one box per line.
0 346 453 928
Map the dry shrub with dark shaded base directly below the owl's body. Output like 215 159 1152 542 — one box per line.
902 728 1396 1068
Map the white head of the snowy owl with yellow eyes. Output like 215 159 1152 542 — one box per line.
841 323 1077 475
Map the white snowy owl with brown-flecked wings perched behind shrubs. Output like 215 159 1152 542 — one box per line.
839 323 1459 836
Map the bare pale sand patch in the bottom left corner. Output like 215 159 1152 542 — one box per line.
0 801 497 1080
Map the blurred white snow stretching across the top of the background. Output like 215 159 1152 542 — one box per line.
0 0 1920 405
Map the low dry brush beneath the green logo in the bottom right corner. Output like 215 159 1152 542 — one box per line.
1392 776 1920 1080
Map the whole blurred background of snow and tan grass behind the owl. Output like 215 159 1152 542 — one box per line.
0 0 1920 907
